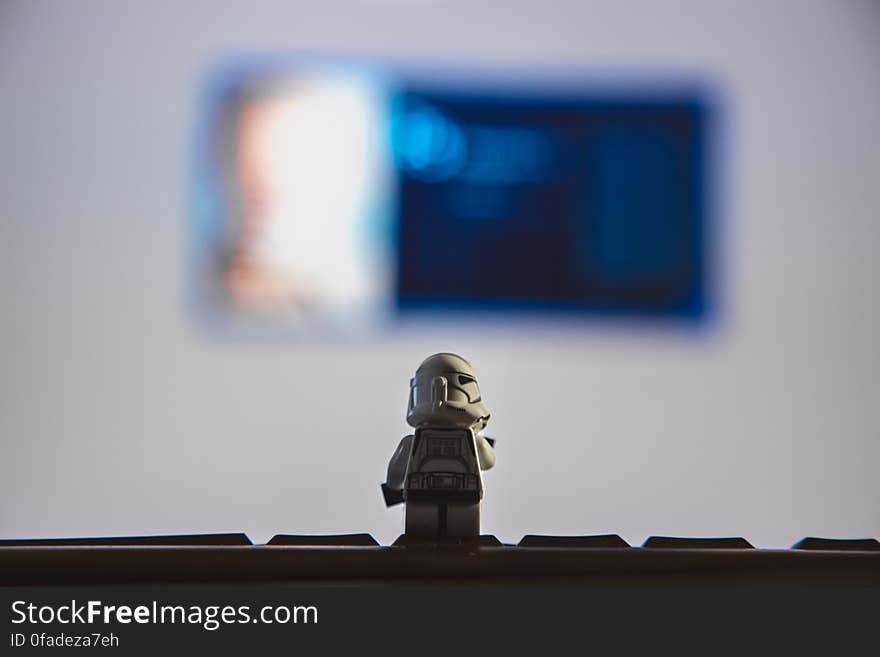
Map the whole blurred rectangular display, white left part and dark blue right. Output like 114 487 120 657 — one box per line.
193 59 711 336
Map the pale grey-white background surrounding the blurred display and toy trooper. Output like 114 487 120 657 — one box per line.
0 0 880 547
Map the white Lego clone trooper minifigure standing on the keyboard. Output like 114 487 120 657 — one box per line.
382 353 495 540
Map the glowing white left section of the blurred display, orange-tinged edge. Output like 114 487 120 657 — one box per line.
233 72 388 312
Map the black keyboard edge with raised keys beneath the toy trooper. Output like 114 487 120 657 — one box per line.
0 533 880 587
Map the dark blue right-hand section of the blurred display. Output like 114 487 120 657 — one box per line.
395 89 704 316
